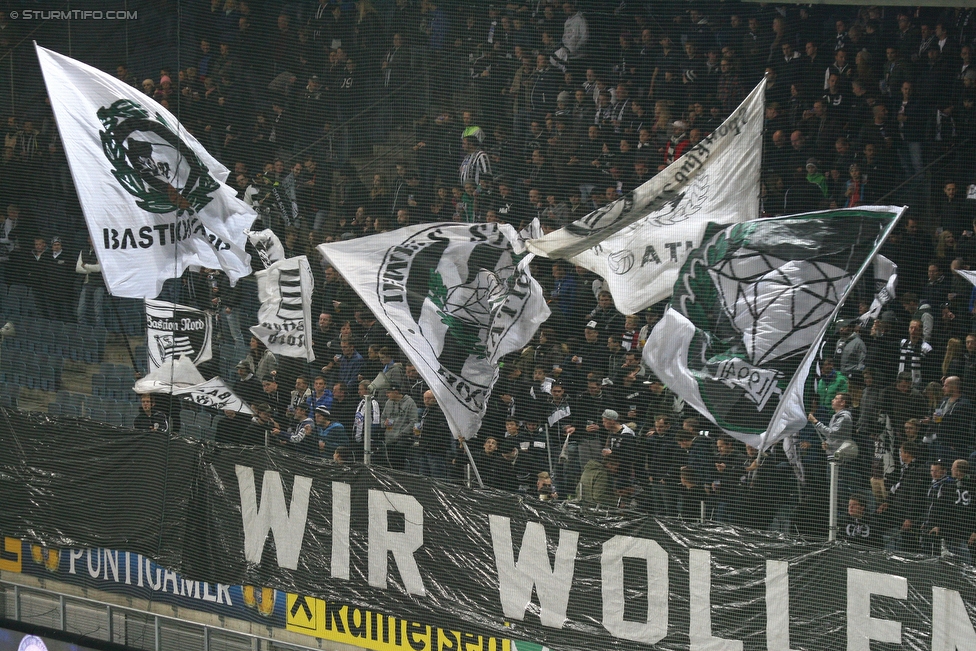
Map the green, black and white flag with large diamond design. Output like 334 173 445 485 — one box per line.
643 206 904 449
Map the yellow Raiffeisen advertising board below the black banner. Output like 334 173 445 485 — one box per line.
285 593 511 651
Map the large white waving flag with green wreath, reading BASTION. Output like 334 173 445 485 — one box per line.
36 46 255 298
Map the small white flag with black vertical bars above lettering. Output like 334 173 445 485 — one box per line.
251 255 315 362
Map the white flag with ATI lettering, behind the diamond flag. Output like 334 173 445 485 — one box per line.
528 81 766 314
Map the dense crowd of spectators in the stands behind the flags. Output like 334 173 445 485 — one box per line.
0 0 976 559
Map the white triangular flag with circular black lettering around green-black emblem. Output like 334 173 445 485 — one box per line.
319 224 550 438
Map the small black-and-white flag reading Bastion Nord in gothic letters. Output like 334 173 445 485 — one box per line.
146 300 213 372
